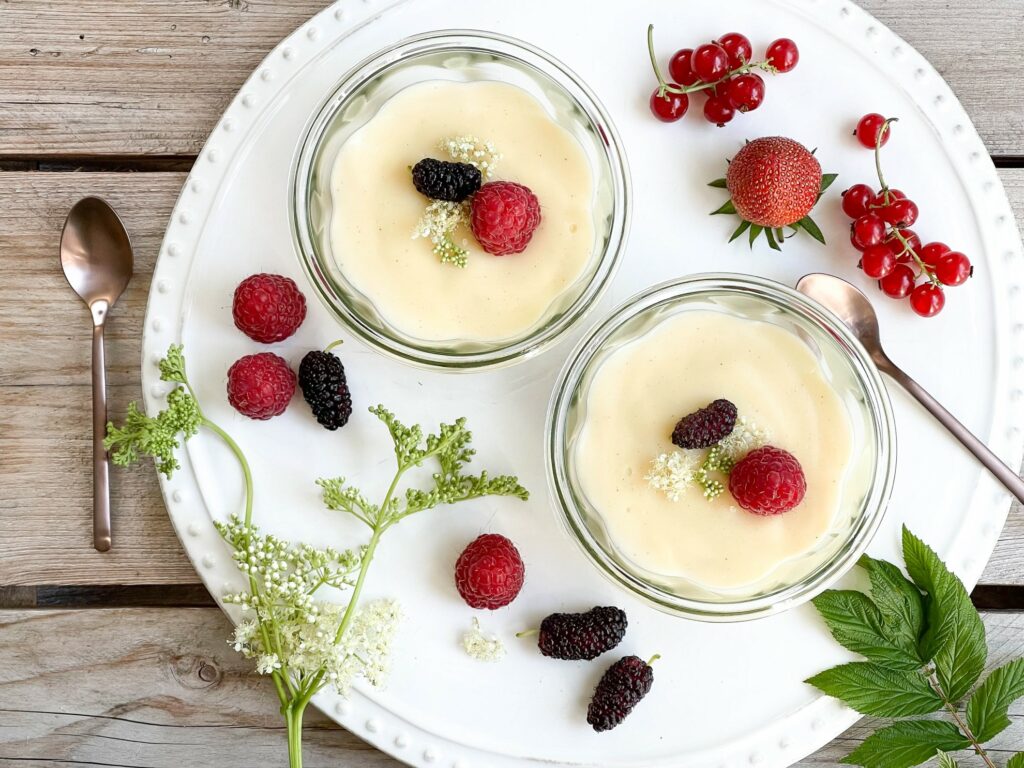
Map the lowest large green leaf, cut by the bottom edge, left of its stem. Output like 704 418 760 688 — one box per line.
840 720 970 768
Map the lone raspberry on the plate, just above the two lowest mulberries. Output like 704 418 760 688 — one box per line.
455 534 525 610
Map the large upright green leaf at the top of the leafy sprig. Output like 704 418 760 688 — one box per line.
903 526 988 701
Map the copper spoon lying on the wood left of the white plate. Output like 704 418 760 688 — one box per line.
60 198 132 552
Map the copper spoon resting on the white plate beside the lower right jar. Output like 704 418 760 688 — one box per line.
797 274 1024 503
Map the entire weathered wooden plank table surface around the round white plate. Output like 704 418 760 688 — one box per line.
0 0 1024 768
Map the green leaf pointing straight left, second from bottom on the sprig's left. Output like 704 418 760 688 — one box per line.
806 662 943 718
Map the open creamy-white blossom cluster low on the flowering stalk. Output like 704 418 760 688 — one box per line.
228 600 400 695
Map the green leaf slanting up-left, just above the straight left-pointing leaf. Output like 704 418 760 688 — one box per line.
813 590 923 672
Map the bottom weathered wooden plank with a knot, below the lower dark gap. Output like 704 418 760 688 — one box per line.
0 608 1024 768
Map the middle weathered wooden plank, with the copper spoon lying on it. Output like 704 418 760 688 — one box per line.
0 170 1024 586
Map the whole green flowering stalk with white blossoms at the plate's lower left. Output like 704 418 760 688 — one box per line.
105 345 529 768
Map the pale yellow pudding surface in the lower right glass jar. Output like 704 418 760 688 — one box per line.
574 310 852 590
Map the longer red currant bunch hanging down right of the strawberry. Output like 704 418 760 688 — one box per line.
843 114 974 317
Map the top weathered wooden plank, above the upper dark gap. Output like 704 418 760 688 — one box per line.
0 0 1024 158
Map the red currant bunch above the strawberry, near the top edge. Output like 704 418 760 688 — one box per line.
647 25 800 126
